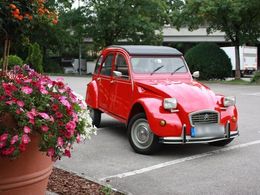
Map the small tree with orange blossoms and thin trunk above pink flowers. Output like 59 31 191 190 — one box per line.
0 0 57 72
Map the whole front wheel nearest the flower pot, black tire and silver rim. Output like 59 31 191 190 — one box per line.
128 113 160 154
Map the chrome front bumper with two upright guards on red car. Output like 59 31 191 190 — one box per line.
159 122 239 144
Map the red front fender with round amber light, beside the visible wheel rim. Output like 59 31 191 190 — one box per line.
137 98 182 137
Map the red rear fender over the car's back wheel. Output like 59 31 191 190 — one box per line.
85 80 98 109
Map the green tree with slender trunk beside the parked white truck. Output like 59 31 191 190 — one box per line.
169 0 260 79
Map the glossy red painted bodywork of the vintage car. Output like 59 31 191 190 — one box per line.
86 47 238 142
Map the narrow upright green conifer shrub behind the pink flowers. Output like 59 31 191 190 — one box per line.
26 43 43 72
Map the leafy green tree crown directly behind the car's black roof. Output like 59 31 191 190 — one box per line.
85 0 169 47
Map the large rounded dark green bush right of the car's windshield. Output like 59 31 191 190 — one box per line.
185 43 232 80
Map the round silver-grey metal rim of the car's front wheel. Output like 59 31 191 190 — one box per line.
131 119 154 149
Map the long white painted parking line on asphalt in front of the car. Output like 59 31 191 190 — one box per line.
99 140 260 181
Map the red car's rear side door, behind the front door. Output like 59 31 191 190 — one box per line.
97 53 115 112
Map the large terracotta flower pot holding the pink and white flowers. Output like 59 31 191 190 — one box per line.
0 136 52 195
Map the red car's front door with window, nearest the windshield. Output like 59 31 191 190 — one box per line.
110 53 132 119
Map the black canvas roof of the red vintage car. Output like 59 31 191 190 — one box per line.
111 45 182 55
